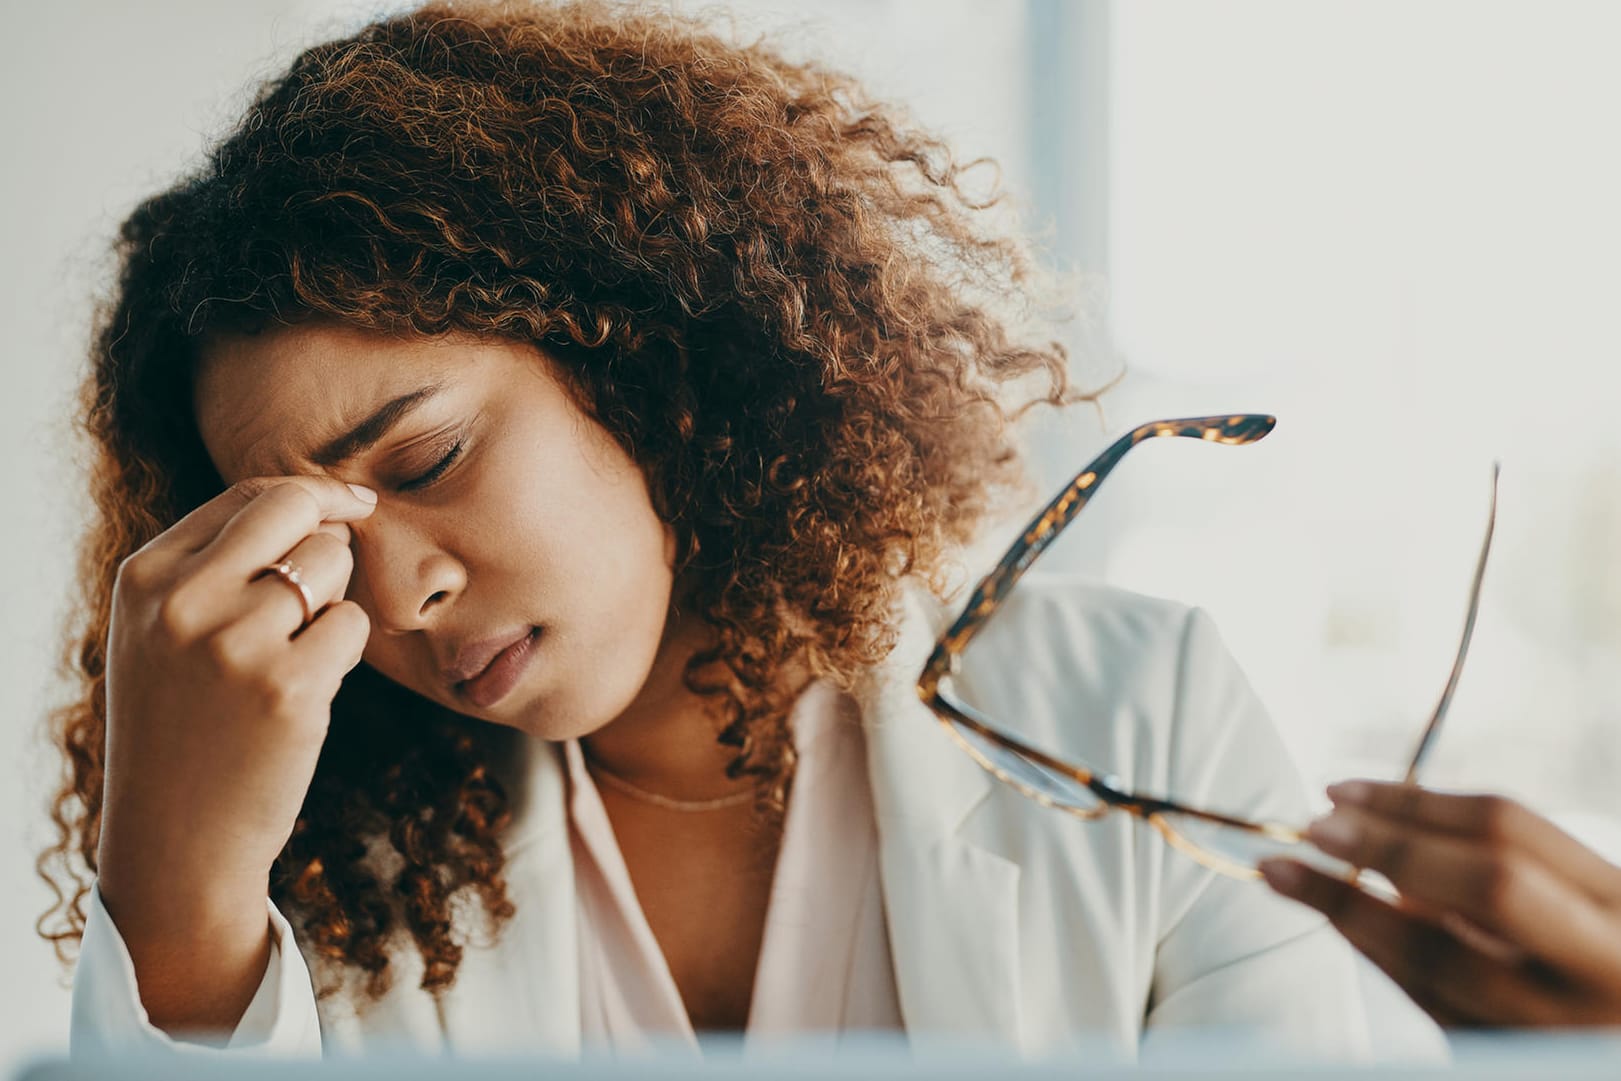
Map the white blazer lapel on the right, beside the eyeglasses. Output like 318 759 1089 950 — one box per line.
859 588 1020 1045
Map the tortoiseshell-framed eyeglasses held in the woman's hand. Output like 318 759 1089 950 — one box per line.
917 413 1498 880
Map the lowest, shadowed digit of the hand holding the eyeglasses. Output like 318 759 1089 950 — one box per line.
1261 859 1563 1028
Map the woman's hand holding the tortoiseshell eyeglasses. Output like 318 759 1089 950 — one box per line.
1261 781 1621 1028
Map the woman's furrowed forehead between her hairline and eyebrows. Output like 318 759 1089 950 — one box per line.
193 326 479 480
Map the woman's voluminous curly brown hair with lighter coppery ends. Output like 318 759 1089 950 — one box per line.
39 0 1075 995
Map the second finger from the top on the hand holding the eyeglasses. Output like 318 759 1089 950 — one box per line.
1307 807 1621 974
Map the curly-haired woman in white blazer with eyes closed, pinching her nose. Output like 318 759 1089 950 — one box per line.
53 5 1387 1053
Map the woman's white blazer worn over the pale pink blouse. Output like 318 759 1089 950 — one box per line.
73 575 1419 1057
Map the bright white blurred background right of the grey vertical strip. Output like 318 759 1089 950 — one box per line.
1107 0 1621 820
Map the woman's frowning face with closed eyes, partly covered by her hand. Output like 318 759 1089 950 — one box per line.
196 326 674 739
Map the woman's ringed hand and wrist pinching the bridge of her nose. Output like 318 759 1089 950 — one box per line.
97 476 376 1028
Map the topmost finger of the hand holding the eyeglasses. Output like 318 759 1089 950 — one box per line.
1328 781 1621 904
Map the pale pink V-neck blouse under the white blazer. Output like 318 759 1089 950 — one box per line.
564 682 901 1052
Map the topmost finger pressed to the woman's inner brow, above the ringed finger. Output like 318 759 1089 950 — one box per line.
201 476 376 575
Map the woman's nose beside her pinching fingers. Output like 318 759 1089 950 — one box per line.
349 514 467 634
